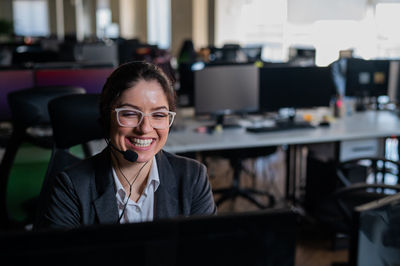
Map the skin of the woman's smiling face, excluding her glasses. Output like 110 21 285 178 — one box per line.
110 80 169 162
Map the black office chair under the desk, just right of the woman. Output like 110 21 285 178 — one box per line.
203 147 276 209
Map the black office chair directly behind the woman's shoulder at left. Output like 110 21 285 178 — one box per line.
36 94 104 227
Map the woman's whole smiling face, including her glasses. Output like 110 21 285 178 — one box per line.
110 80 171 162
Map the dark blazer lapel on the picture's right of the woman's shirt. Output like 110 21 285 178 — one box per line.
155 151 180 219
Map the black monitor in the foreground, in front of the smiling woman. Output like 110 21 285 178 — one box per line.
0 208 297 266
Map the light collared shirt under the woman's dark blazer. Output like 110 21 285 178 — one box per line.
112 157 160 223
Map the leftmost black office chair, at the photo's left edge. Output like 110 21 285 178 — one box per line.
0 86 85 228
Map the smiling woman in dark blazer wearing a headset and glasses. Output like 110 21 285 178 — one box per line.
38 62 216 229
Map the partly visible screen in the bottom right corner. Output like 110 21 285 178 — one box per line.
349 193 400 266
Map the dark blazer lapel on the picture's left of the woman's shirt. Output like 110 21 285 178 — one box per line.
93 148 118 224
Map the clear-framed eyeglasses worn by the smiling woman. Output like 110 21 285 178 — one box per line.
114 108 176 129
